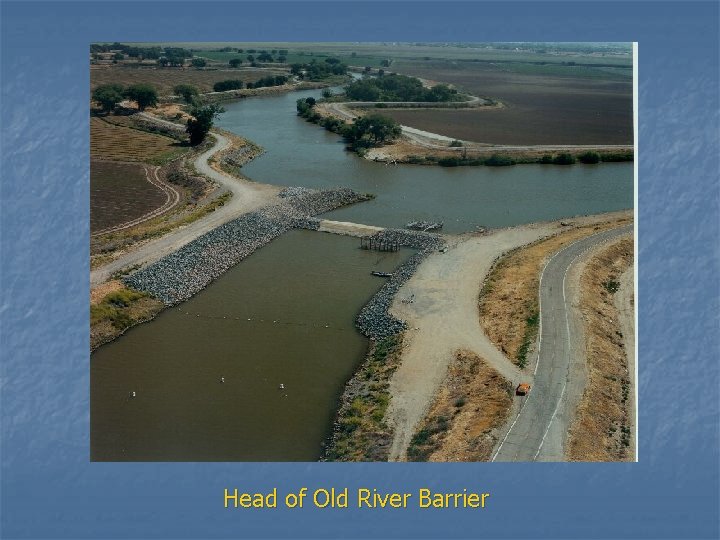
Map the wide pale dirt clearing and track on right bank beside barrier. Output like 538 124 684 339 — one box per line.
386 219 560 460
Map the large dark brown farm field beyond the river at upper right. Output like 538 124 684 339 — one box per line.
383 61 633 145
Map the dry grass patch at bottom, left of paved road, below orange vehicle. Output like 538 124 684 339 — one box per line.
408 351 512 462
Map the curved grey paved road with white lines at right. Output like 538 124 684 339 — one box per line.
492 225 633 461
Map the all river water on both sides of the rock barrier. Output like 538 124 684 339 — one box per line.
91 84 633 461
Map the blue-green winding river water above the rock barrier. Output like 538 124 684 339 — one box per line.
218 90 633 233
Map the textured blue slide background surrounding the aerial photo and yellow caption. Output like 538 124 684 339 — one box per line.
0 2 720 538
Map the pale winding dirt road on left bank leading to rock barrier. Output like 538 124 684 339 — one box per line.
90 130 280 288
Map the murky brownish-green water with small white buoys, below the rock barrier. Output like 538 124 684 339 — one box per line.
91 231 411 461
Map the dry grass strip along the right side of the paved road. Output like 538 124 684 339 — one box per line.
567 236 634 461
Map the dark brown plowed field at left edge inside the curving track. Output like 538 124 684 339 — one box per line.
90 160 166 233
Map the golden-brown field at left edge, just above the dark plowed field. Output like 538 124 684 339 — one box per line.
90 116 189 165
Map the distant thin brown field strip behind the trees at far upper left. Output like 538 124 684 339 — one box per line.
90 66 287 95
